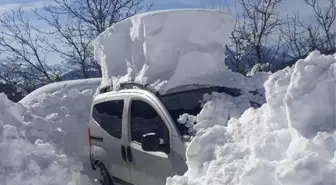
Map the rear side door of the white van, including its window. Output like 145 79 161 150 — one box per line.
93 96 131 184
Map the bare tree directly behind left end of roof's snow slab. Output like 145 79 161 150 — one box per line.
35 0 151 78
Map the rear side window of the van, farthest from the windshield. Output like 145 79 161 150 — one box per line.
92 100 124 139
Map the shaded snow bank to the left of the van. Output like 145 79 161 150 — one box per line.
0 80 100 185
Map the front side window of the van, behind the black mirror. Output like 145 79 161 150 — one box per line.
131 100 169 145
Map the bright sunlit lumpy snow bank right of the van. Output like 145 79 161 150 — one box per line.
167 51 336 185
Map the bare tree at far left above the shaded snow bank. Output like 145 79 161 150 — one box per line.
0 9 60 92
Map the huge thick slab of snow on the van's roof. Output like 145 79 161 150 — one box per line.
94 9 262 91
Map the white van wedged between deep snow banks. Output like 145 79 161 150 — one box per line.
89 83 240 185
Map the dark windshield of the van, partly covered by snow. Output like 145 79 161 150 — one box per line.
159 87 240 136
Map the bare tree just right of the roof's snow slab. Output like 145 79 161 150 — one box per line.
226 0 283 74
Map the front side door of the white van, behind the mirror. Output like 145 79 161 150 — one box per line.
127 97 174 185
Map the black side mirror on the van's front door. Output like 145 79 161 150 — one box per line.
141 133 160 152
